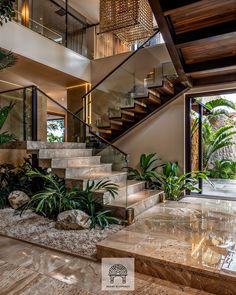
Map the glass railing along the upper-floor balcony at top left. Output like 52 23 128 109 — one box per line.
13 0 89 56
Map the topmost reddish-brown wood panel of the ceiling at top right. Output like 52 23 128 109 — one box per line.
170 0 236 34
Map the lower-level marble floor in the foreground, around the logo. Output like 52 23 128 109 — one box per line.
0 236 213 295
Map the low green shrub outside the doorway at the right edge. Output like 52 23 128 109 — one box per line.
209 160 236 179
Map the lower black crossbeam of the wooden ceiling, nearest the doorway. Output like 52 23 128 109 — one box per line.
184 56 236 74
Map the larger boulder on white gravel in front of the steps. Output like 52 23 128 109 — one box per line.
56 209 91 230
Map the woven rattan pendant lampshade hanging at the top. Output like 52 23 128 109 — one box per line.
100 0 153 43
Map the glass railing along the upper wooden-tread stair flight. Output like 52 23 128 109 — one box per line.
77 31 176 140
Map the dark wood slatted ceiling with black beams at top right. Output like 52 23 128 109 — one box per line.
149 0 236 85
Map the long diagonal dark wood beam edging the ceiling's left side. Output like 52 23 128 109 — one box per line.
148 0 192 87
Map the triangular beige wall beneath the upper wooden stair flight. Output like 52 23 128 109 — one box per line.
115 96 185 170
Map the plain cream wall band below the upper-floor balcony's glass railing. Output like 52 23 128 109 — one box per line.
0 21 91 82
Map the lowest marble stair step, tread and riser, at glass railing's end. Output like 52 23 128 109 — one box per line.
105 190 163 219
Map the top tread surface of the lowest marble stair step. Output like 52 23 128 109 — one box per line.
107 190 161 208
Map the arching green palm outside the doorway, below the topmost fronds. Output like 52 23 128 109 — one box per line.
202 124 236 170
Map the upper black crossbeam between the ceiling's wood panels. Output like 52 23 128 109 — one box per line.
173 21 236 48
